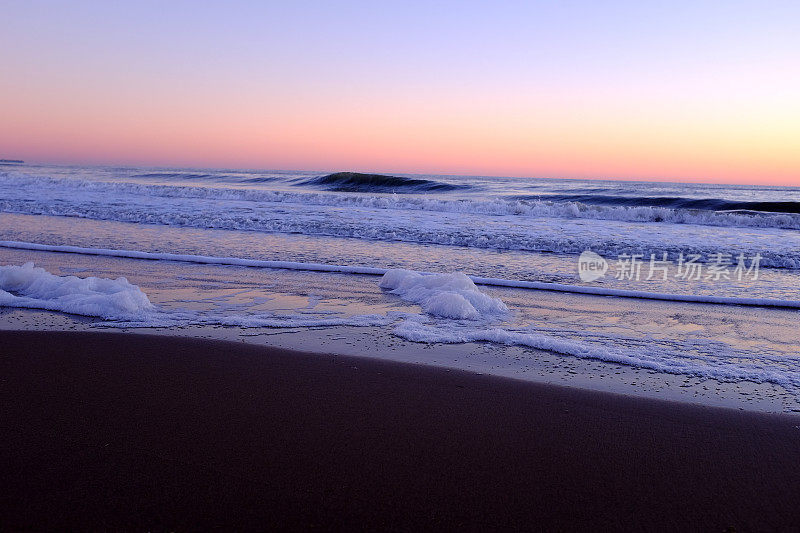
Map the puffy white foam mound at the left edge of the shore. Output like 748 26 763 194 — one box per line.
0 263 154 319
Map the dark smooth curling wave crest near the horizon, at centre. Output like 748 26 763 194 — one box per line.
296 172 471 193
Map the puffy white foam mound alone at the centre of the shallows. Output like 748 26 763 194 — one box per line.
380 269 508 320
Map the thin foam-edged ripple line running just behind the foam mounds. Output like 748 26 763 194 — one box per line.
0 241 800 309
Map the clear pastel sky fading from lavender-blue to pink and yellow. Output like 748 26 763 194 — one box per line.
0 0 800 185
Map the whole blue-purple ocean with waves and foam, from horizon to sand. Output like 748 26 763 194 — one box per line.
0 164 800 408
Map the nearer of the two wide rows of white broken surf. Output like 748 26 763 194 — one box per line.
0 197 800 269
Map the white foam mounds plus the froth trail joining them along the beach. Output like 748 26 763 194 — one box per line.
0 263 800 393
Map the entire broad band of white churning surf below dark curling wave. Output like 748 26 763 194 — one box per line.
0 172 800 269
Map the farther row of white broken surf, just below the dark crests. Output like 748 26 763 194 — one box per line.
0 172 800 229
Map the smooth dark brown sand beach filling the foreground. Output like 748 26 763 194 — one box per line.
0 331 800 531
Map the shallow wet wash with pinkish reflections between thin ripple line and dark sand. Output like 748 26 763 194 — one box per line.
0 242 800 412
